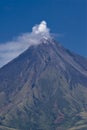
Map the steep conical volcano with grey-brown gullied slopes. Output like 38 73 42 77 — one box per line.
0 38 87 130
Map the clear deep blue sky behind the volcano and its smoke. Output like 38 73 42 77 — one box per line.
0 0 87 57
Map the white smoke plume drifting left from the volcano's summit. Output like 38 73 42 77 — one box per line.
0 21 51 67
